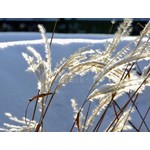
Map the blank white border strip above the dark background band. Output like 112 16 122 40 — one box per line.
0 0 149 18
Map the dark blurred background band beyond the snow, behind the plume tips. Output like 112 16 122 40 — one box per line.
0 18 150 35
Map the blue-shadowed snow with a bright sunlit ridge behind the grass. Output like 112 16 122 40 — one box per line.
0 32 150 131
